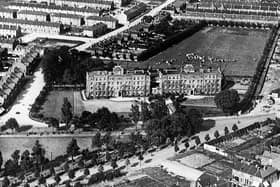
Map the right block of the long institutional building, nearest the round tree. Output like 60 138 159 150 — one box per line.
153 64 222 95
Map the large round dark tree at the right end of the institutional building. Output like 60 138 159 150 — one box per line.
214 89 240 113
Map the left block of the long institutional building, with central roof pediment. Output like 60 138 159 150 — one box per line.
86 66 151 98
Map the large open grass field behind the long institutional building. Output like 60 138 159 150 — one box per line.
143 27 270 76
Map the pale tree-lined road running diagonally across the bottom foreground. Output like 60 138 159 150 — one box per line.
27 114 275 187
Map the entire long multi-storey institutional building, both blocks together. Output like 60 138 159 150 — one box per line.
86 64 222 98
